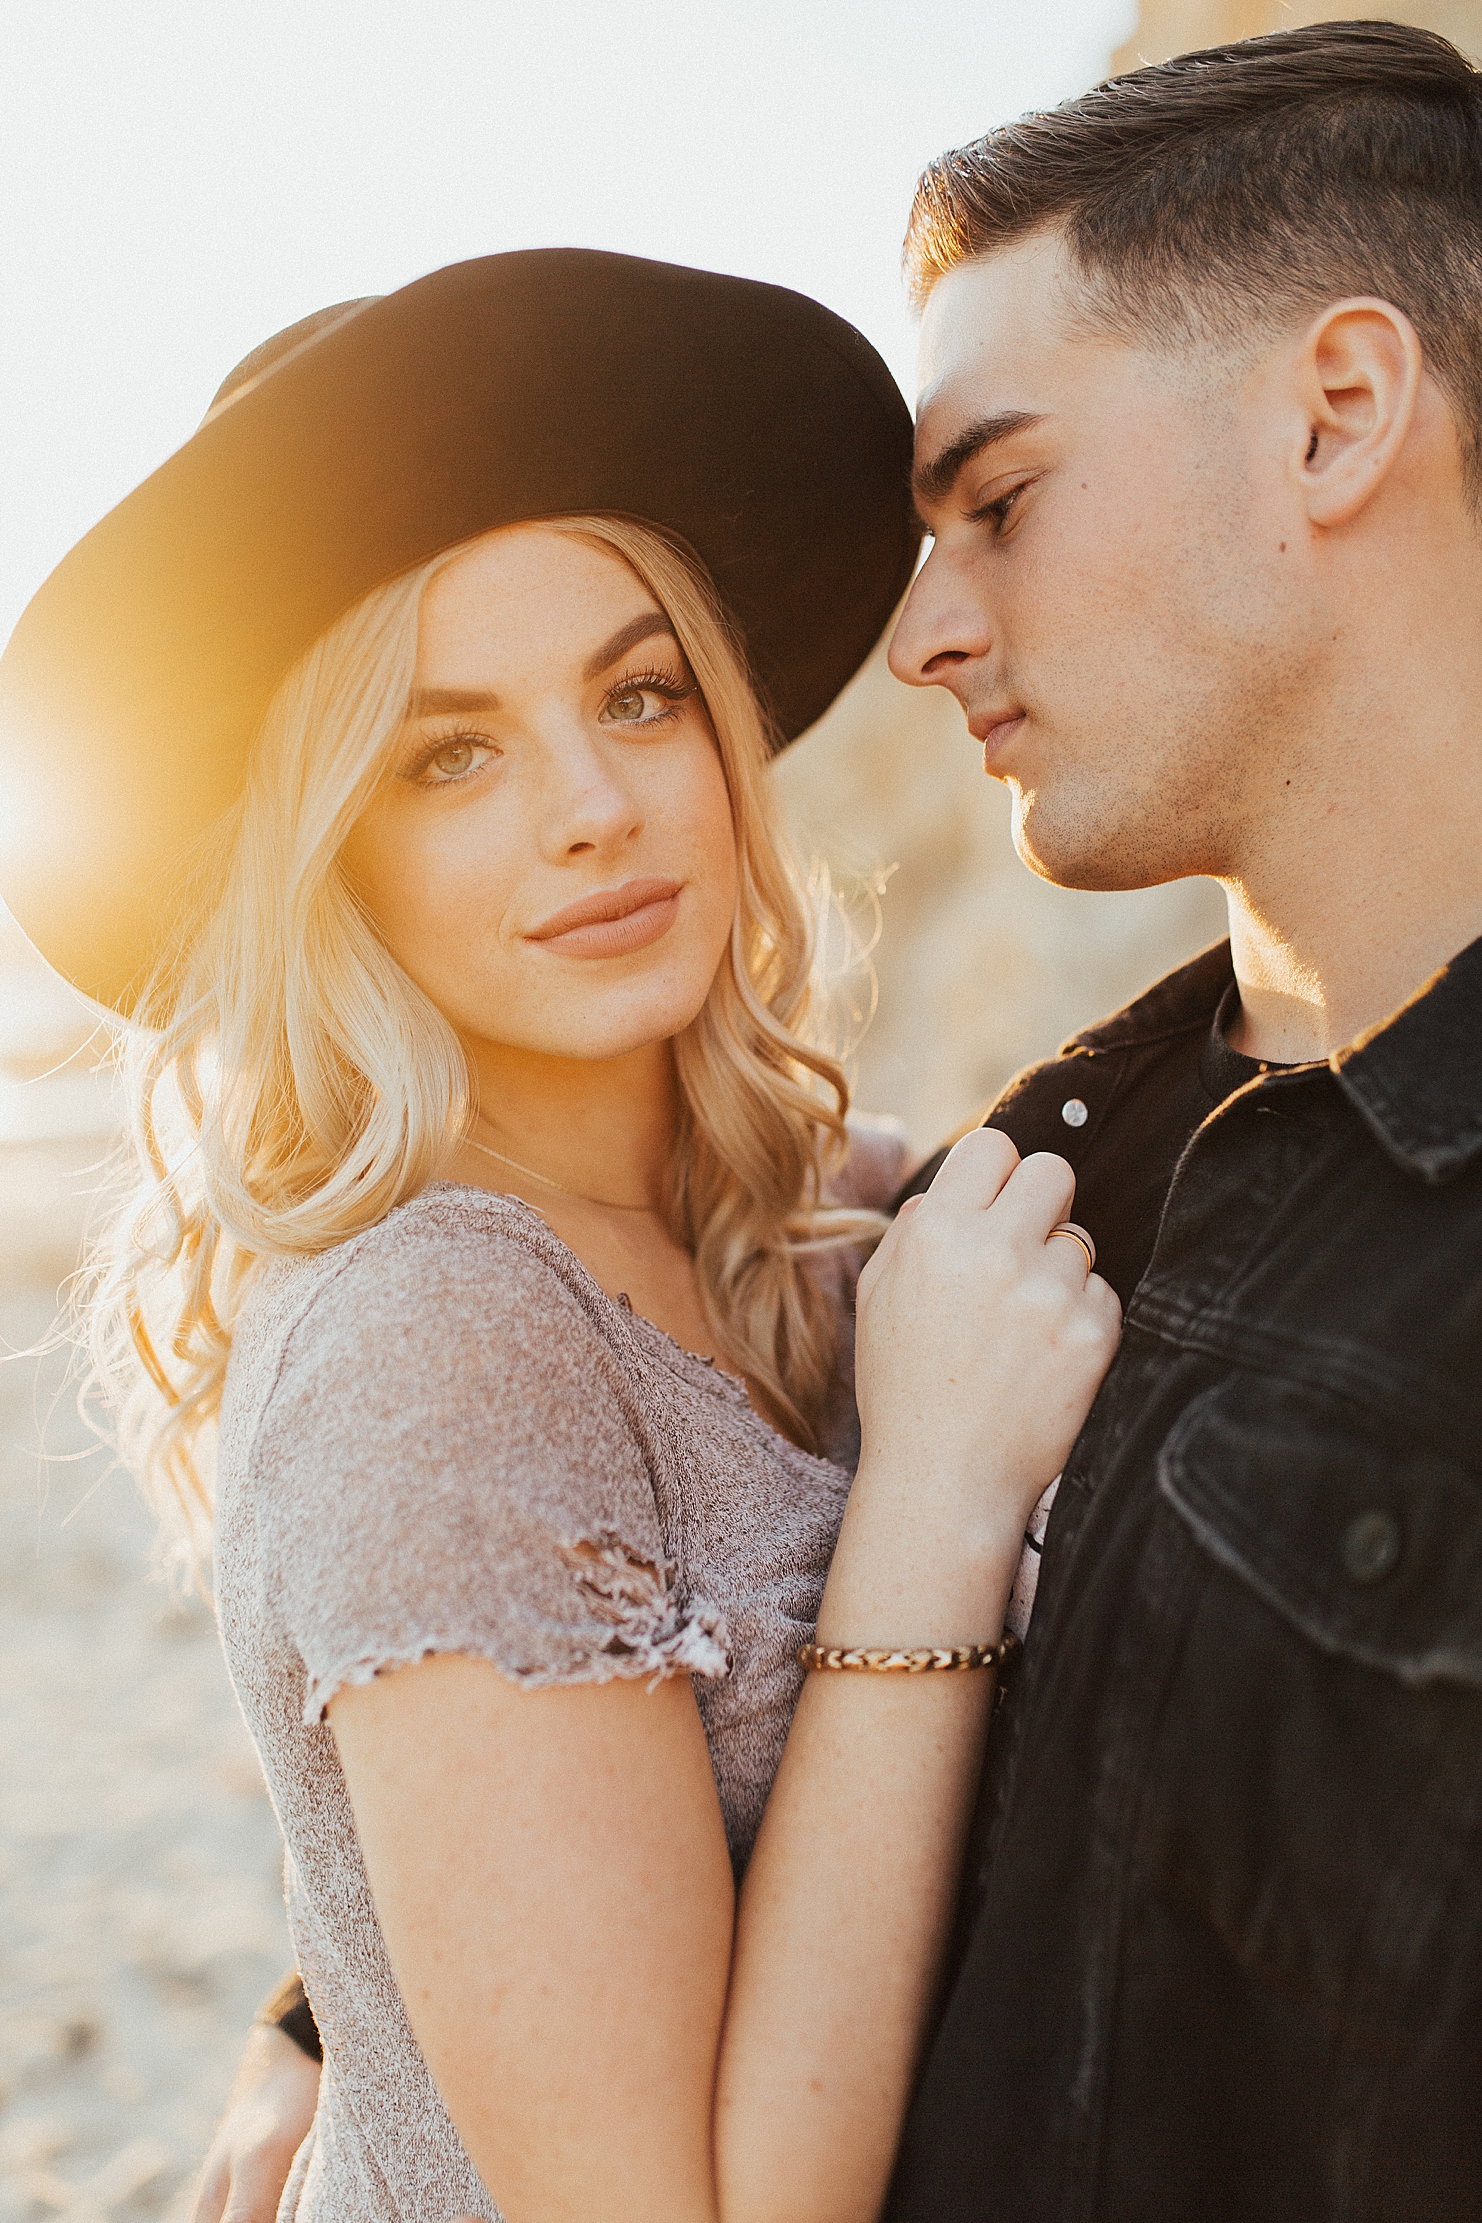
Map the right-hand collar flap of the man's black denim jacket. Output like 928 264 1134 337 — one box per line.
1329 940 1482 1185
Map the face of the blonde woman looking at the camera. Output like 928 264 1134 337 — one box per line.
344 525 735 1058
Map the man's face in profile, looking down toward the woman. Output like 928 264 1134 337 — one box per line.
891 236 1331 887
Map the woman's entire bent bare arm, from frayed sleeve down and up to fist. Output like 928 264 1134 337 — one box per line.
331 1132 1115 2223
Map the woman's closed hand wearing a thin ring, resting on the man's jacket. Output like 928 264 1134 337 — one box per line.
858 1127 1122 1556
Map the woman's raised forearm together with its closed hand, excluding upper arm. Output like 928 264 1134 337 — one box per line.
715 1132 1118 2223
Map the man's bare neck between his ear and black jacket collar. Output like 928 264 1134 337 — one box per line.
1209 411 1482 1063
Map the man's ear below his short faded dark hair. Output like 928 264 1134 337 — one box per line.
1293 298 1424 527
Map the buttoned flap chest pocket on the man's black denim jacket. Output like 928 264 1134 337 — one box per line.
1144 1376 1482 2047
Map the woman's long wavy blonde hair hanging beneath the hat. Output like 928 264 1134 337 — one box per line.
80 516 882 1561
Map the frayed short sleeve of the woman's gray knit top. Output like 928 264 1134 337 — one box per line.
251 1205 729 1723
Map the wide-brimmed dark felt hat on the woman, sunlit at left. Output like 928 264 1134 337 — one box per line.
0 249 920 1009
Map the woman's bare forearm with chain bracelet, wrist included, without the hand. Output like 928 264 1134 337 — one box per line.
715 1469 1022 2223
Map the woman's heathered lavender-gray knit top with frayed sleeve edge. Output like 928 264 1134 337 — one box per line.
216 1132 902 2223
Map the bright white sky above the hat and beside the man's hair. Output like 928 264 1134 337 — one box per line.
0 0 1135 640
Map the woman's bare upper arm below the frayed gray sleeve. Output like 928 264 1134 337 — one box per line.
329 1658 733 2223
